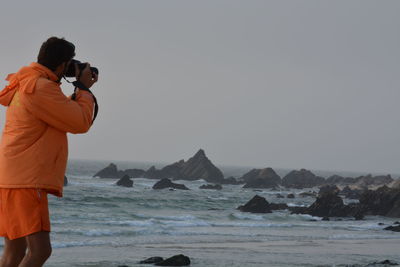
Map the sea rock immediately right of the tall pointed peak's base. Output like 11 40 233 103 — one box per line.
240 168 281 188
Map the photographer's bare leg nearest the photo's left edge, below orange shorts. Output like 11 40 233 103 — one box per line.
0 237 26 267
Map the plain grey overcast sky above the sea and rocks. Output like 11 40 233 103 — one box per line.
0 0 400 173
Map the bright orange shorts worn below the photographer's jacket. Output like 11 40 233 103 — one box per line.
0 188 50 240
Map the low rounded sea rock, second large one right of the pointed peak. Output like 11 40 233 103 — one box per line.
282 169 325 189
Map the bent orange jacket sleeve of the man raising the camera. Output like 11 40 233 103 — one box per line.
23 79 94 134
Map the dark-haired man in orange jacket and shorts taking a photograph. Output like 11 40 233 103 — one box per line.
0 37 98 267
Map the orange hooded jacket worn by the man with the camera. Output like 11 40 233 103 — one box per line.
0 63 94 196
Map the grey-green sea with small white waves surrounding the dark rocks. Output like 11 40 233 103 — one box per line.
1 160 400 267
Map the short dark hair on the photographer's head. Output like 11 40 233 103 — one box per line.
37 37 75 71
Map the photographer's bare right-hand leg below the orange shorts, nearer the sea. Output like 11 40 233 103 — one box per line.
19 232 51 267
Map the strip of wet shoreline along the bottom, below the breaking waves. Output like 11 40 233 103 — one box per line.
46 240 400 267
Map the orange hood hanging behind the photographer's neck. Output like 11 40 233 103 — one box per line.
0 62 58 106
